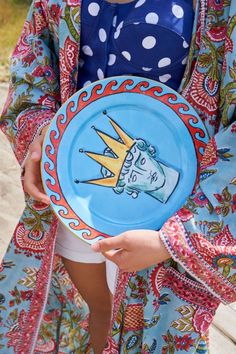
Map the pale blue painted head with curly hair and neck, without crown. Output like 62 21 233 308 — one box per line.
101 139 180 203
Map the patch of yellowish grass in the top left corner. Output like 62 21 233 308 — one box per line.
0 0 29 82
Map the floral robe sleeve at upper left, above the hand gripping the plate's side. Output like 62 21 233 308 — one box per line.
0 1 60 165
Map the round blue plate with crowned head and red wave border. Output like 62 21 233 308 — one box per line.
42 76 208 244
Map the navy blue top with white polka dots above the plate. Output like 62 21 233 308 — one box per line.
78 0 194 90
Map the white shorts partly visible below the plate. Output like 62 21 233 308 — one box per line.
55 222 118 294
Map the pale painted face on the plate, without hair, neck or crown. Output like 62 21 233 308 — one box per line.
121 145 166 192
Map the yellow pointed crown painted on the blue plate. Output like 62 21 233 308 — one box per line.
83 116 135 187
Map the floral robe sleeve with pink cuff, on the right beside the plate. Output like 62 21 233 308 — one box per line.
160 117 236 304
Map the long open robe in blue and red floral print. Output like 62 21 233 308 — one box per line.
0 0 236 354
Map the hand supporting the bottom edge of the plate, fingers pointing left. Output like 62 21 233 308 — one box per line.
92 230 171 272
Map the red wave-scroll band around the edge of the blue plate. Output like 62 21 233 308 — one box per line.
43 79 206 240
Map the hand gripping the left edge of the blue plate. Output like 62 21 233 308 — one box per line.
24 127 50 204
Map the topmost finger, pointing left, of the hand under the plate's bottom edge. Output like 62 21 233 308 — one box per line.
91 234 127 252
